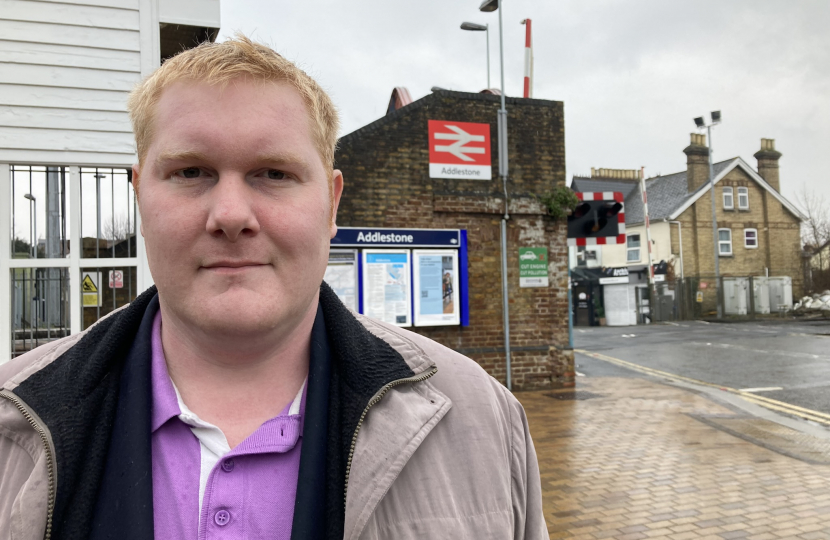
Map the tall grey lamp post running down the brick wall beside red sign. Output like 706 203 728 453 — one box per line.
478 0 513 390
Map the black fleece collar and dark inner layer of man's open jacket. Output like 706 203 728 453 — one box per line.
15 283 413 540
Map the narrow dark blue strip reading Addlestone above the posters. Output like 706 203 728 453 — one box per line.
331 227 461 248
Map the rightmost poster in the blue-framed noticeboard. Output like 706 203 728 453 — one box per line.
412 249 461 326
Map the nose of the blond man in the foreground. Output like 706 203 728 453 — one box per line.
207 175 259 242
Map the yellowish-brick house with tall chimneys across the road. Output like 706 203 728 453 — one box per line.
571 133 805 320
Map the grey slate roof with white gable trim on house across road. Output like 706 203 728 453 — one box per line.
571 157 804 225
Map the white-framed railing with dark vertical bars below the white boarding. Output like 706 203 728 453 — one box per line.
0 163 145 363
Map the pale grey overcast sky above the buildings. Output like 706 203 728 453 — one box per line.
219 0 830 209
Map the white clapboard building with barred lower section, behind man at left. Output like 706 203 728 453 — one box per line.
0 0 219 363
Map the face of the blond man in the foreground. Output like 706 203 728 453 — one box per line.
134 79 343 337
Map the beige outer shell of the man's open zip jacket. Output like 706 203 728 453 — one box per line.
0 310 548 540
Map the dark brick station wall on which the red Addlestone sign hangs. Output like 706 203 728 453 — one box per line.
335 88 574 389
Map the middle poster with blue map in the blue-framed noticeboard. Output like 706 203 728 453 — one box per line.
363 249 412 326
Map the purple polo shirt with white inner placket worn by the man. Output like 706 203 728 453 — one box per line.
150 311 306 540
